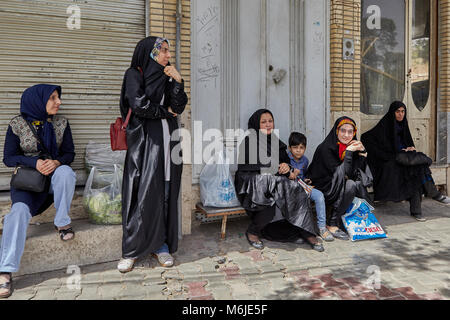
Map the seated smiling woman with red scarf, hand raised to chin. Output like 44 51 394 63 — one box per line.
306 117 372 240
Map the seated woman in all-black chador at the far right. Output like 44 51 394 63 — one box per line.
361 101 450 221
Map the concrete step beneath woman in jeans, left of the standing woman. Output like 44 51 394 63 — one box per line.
14 219 122 275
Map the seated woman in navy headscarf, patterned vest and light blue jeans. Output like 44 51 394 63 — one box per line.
0 84 76 298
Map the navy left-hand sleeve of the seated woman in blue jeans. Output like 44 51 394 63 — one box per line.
3 126 39 168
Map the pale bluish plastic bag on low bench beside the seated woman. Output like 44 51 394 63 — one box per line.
200 152 241 208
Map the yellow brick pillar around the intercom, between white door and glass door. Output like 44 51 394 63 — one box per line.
330 0 361 112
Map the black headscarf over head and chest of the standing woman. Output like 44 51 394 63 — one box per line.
131 36 170 103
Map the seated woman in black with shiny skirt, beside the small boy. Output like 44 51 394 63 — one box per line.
235 109 324 251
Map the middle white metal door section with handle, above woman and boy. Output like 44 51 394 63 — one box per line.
239 0 303 143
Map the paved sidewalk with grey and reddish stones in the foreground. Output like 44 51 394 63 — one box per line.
1 199 450 300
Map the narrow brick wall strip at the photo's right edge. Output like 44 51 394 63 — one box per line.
439 0 450 112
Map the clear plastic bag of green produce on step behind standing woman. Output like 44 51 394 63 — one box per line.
83 165 123 224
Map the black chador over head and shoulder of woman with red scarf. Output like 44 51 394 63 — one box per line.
307 116 356 190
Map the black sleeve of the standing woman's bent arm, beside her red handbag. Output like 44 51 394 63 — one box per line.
125 68 171 119
